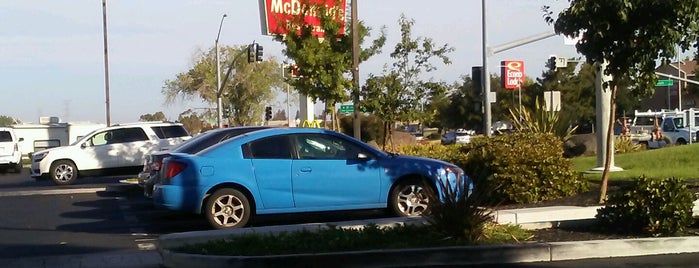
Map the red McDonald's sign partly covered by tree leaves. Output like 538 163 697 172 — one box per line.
260 0 347 38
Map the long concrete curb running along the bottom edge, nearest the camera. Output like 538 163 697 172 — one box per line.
160 237 699 267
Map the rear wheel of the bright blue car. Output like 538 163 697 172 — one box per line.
203 189 252 229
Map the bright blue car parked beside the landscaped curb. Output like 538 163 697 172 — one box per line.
153 128 471 228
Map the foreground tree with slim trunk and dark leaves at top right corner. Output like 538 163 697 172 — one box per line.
545 0 699 203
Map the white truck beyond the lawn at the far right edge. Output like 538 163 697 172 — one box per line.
628 109 699 148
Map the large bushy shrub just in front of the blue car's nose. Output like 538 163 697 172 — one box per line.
461 133 588 204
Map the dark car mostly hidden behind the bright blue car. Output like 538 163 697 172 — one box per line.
138 126 269 197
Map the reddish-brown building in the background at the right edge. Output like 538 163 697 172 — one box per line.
641 60 699 111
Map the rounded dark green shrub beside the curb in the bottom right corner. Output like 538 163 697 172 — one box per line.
596 176 694 236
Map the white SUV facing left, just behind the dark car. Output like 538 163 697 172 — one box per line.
31 122 191 185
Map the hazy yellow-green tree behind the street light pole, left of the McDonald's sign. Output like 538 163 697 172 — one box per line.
162 46 283 125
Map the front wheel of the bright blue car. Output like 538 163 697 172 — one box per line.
389 179 429 217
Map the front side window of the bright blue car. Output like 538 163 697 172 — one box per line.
295 134 366 160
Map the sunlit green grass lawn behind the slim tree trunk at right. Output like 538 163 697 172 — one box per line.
571 144 699 180
